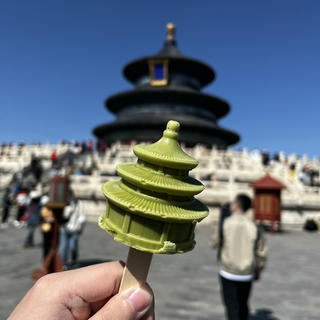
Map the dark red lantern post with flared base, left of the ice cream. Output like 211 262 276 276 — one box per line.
32 176 69 280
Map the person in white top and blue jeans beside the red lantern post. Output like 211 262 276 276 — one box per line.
59 196 86 266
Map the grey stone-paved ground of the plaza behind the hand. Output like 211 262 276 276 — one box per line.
0 223 320 320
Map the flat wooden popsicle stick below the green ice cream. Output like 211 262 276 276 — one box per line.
119 248 152 293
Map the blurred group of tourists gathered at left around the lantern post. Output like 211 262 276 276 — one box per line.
0 149 86 267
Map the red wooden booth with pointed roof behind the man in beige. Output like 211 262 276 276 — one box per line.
250 174 286 232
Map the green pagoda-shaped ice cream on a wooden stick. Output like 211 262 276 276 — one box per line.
99 121 208 253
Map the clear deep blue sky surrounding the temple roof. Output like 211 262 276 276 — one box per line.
0 0 320 157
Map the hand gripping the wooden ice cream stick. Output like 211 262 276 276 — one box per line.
7 262 154 320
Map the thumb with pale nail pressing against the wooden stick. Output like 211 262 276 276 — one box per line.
90 287 153 320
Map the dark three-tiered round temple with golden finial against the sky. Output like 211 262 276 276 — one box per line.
93 23 240 148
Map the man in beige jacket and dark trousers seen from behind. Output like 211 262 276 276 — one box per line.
213 194 266 320
